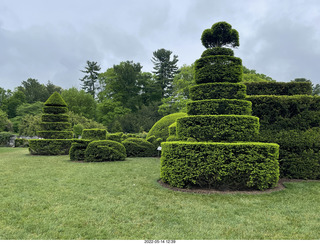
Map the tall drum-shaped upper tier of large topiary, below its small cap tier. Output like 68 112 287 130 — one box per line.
195 55 242 84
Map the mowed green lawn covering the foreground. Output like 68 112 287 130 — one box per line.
0 148 320 240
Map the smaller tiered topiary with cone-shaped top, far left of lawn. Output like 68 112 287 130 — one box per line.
29 92 73 155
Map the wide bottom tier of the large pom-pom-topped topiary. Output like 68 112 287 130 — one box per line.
160 142 279 190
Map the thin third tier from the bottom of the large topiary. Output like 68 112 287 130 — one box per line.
187 99 252 115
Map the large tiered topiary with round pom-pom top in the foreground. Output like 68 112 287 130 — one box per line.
160 22 279 190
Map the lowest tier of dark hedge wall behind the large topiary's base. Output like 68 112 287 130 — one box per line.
257 128 320 180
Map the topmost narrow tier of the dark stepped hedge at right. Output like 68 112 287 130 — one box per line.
244 82 312 96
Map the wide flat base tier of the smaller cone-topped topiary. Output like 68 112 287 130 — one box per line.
29 139 73 155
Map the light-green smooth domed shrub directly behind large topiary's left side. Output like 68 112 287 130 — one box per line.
147 113 187 141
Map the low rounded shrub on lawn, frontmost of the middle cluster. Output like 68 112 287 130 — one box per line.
85 140 126 162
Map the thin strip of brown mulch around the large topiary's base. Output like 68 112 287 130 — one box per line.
158 179 320 194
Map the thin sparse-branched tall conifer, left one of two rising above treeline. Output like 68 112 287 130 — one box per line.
80 61 101 98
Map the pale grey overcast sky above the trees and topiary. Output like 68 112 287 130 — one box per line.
0 0 320 89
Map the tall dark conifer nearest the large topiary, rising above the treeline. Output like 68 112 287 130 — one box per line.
151 48 179 98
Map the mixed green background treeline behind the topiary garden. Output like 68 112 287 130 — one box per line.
0 49 320 136
